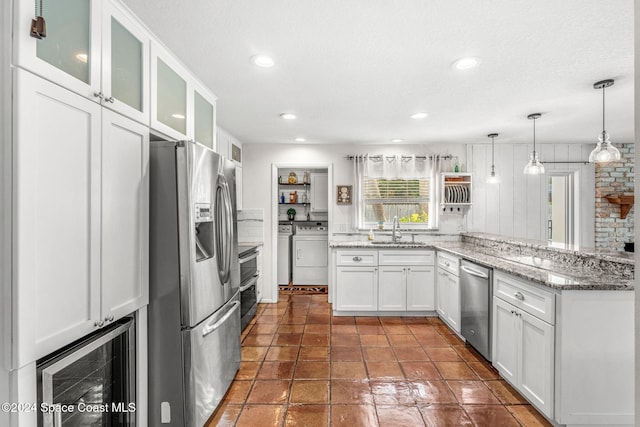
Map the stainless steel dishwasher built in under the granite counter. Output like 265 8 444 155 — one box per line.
460 260 493 361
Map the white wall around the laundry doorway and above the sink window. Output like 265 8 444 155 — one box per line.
242 144 466 302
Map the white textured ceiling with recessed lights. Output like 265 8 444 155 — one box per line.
125 0 634 144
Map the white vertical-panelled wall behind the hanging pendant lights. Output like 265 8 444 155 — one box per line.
467 143 595 247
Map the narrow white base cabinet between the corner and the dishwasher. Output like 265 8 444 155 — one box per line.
436 252 460 333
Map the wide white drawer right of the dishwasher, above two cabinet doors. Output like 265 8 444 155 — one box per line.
493 271 555 325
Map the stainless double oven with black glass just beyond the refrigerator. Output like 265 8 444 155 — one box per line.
238 245 259 329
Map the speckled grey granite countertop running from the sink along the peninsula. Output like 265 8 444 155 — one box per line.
329 241 633 290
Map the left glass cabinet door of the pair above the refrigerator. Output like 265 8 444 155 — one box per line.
156 57 187 135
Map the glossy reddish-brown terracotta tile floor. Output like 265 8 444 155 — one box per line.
207 294 550 427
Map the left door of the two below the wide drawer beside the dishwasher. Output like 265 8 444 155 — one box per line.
492 297 520 385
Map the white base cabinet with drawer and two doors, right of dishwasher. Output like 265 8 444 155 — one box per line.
492 271 555 418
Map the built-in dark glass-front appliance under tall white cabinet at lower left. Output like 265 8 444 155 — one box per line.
36 318 137 427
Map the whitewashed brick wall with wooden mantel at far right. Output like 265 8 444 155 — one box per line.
595 143 635 251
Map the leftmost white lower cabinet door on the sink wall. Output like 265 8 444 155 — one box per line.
336 267 378 311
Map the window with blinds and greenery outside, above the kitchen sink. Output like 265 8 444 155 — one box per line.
362 177 431 228
